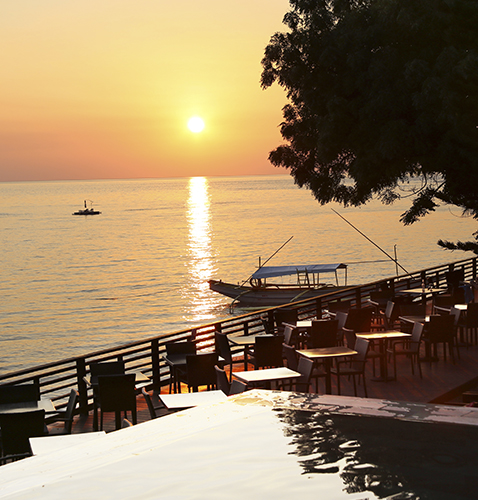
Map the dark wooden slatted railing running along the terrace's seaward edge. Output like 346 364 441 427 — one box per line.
0 258 477 413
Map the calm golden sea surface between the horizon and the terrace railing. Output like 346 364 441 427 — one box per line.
0 175 476 373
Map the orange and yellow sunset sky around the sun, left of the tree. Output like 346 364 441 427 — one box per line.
0 0 289 181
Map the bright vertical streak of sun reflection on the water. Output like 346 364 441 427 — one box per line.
184 177 218 322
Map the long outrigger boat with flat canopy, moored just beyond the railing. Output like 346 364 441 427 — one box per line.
209 264 347 307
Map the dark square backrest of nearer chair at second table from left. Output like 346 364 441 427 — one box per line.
98 373 136 412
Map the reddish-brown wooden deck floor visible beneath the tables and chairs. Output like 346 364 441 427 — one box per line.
63 345 478 433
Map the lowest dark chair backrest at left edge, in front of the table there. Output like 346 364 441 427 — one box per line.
0 410 45 456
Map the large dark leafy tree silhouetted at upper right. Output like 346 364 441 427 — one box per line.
261 0 478 253
